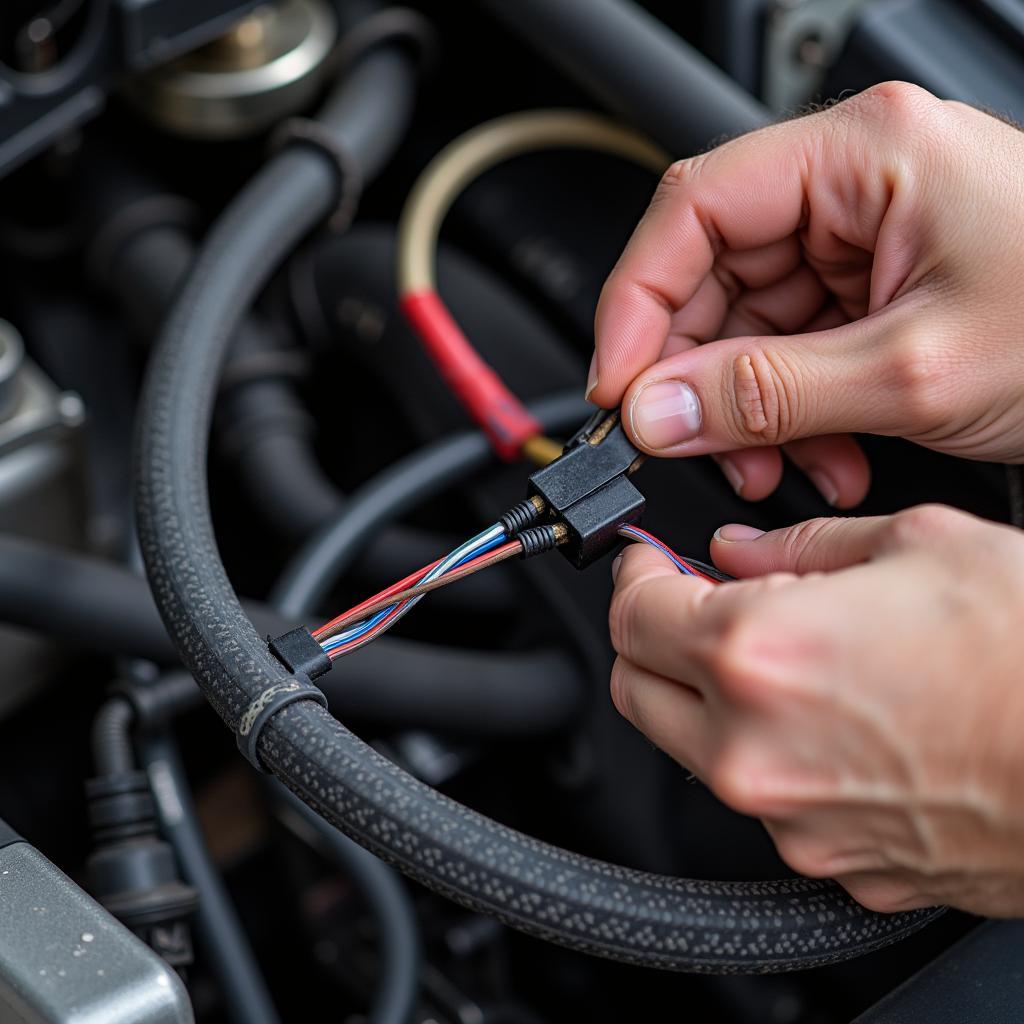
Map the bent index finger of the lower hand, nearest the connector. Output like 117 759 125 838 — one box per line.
608 544 718 689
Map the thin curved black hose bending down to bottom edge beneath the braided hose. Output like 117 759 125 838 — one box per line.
271 781 422 1024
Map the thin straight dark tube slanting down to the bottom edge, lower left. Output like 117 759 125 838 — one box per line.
139 733 280 1024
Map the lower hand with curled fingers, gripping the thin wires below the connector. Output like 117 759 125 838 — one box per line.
610 507 1024 916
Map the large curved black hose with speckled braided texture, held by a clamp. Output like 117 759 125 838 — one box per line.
136 34 937 973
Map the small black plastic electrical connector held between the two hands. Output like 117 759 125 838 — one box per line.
528 410 644 569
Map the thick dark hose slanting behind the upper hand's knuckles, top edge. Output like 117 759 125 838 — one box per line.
482 0 770 157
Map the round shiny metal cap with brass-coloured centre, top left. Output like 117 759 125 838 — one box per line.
130 0 336 138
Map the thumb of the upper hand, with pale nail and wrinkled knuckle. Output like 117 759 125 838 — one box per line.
623 313 912 456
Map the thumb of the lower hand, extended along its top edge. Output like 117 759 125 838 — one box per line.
711 516 898 578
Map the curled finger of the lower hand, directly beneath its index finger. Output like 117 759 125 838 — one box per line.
611 657 711 776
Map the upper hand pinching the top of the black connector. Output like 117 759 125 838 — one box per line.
588 82 1024 507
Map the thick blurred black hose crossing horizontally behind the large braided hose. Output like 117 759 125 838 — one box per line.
0 537 584 739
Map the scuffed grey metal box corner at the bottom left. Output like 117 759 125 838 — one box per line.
0 843 193 1024
